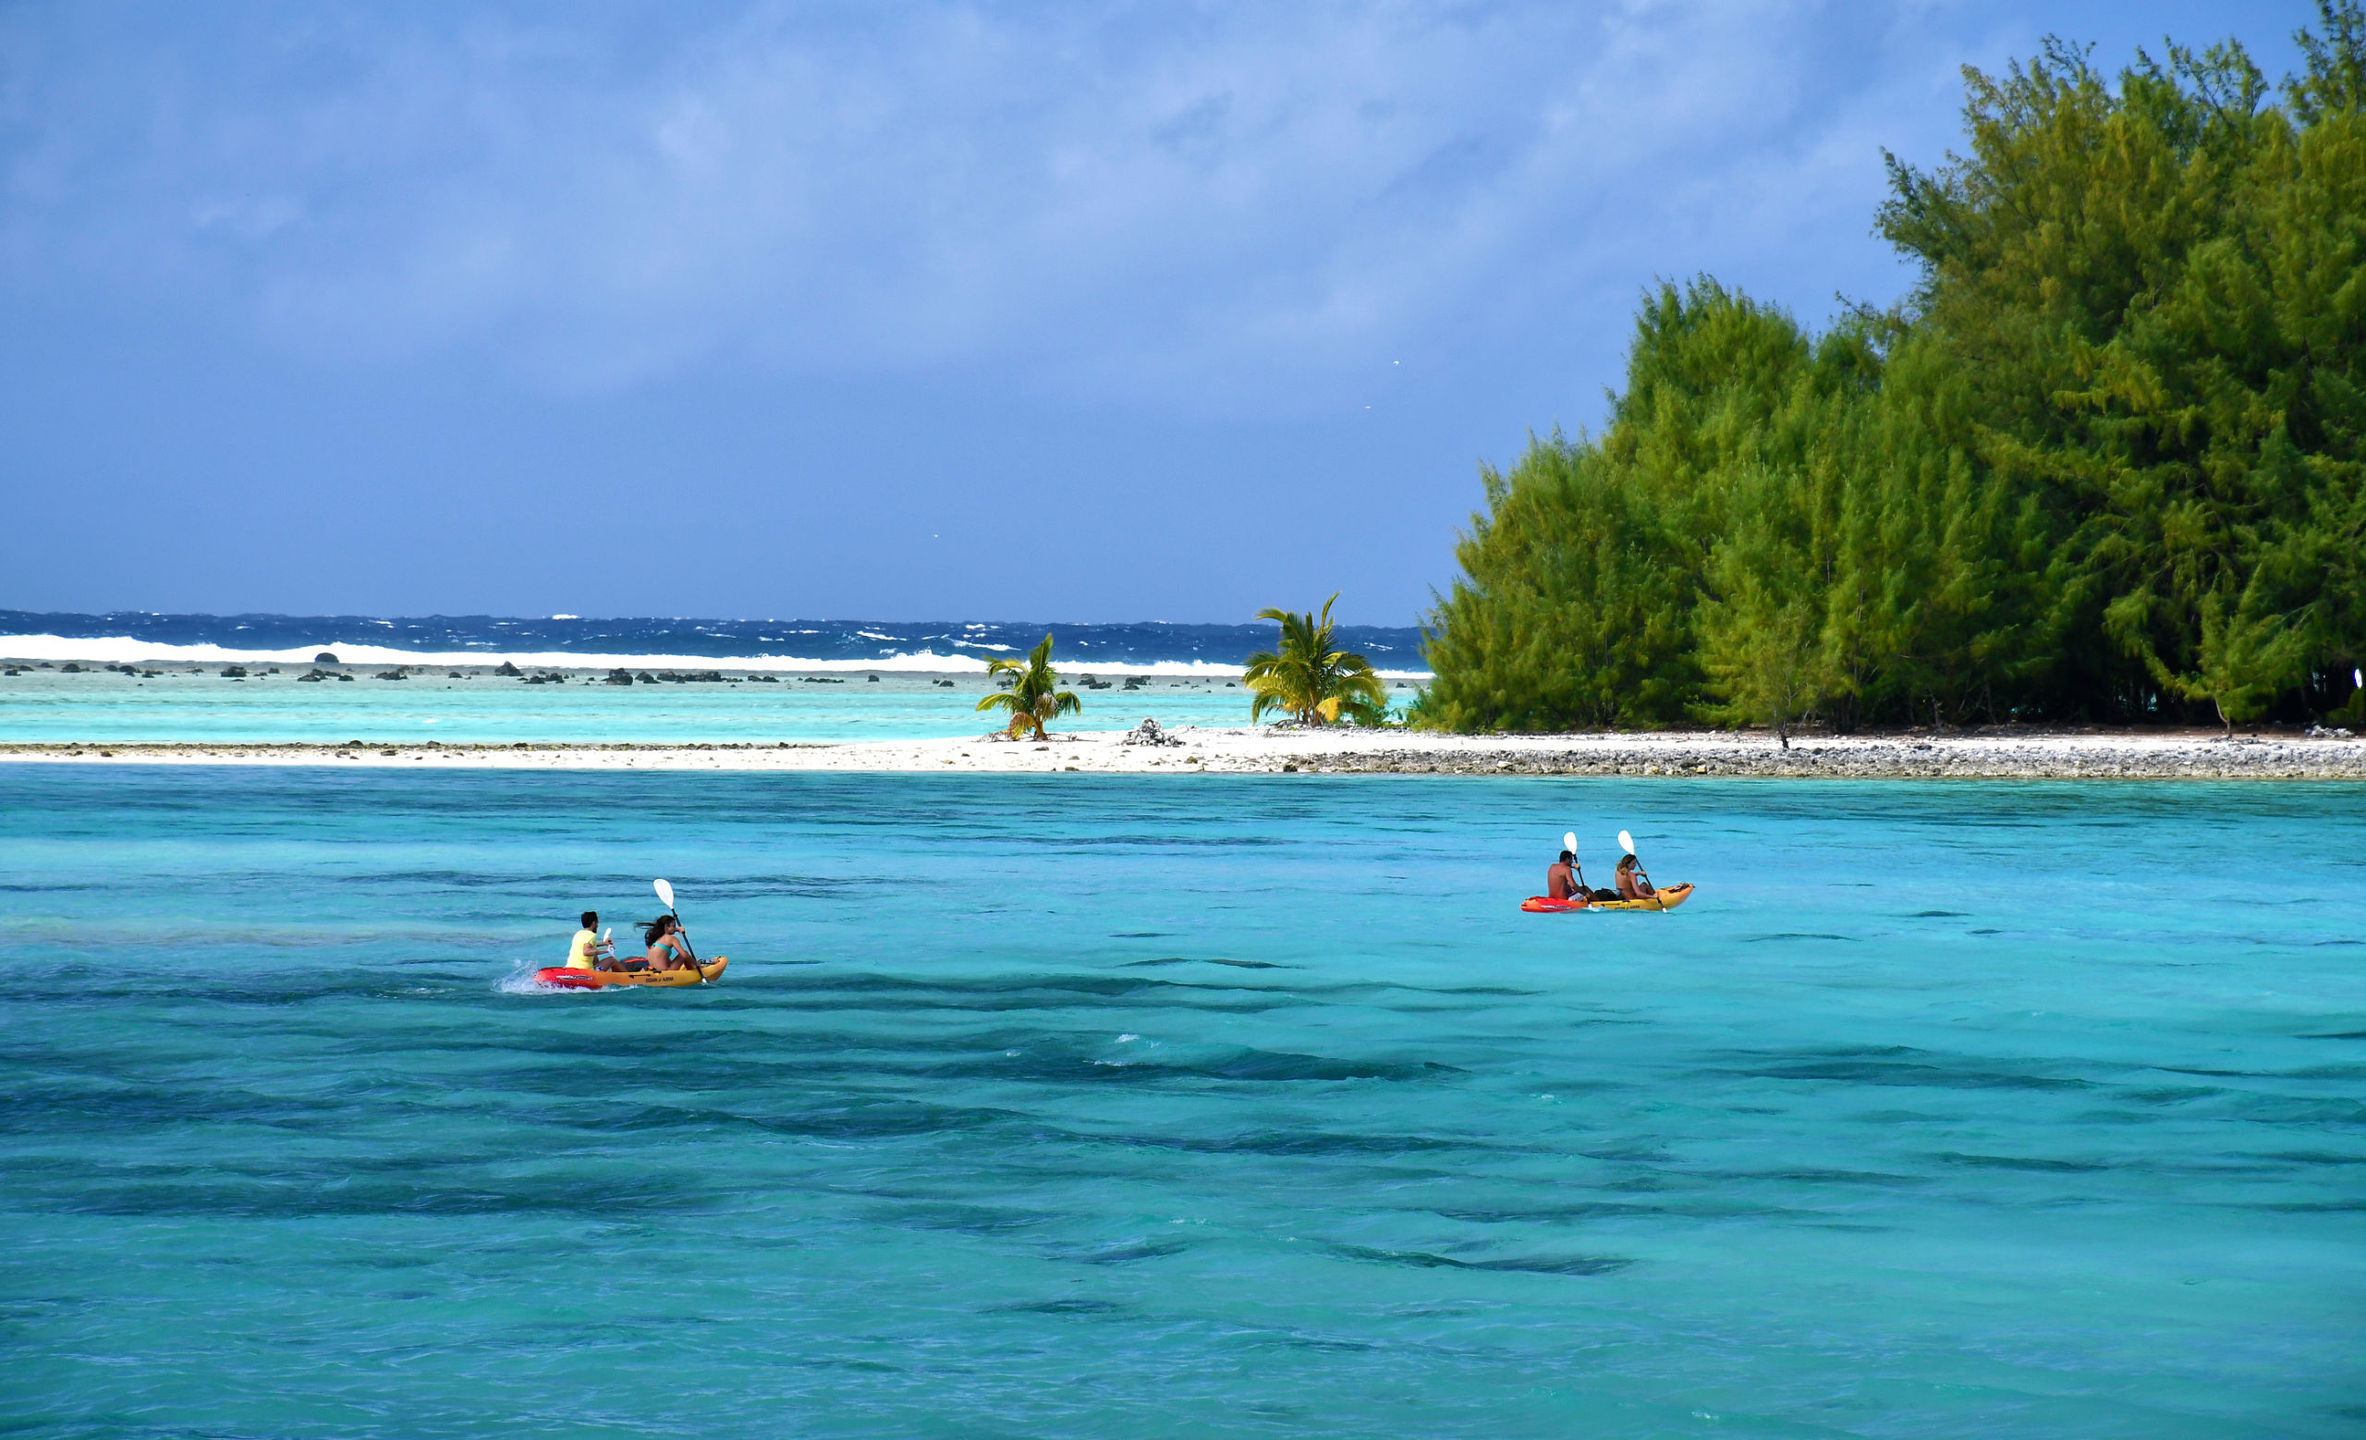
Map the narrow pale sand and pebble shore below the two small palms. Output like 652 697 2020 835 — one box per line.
0 726 2366 780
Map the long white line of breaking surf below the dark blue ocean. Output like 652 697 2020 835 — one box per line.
0 636 1429 683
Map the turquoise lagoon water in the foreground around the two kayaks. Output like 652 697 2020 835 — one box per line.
0 766 2366 1440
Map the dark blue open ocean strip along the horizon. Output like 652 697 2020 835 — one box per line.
0 610 1422 669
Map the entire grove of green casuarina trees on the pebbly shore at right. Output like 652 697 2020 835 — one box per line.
1413 19 2366 735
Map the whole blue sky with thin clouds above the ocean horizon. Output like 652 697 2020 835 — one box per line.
0 0 2314 624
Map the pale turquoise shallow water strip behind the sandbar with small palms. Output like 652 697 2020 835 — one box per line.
0 667 1353 745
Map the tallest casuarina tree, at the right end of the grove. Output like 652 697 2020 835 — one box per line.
1881 5 2366 724
